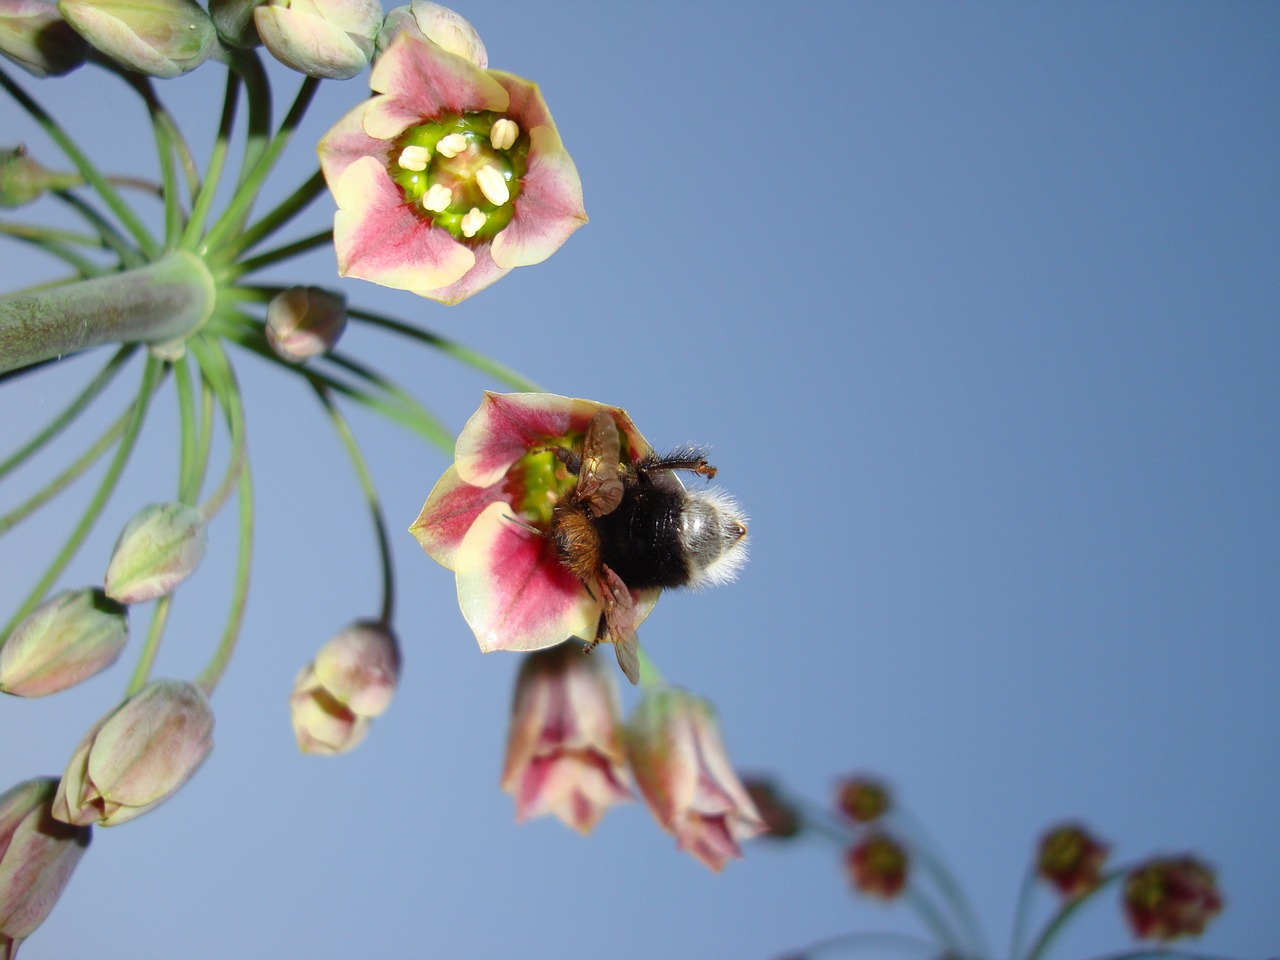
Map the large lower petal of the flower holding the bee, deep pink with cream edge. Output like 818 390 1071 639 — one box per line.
454 504 600 653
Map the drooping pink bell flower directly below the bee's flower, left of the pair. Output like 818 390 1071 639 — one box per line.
502 644 631 833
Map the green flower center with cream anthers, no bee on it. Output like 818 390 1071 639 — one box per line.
390 111 529 243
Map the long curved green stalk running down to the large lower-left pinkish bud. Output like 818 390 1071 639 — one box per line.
192 337 253 695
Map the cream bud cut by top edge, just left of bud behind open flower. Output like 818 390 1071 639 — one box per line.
253 0 383 79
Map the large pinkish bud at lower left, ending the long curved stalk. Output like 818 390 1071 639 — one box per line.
54 680 214 827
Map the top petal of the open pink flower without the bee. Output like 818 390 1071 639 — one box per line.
365 33 508 140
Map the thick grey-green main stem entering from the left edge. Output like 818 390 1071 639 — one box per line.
0 251 218 371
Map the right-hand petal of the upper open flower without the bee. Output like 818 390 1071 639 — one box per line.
493 127 586 268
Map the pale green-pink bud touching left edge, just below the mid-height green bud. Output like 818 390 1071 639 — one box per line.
0 589 129 696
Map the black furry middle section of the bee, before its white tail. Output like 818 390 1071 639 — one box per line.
595 477 689 590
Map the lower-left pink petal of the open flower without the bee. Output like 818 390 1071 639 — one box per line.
332 156 475 293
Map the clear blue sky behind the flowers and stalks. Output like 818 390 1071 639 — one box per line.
0 0 1280 960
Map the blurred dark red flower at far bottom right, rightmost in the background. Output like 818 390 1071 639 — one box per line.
1124 854 1222 940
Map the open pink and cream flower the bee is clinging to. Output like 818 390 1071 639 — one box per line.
410 393 659 653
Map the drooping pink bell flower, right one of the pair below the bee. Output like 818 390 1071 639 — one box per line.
625 687 765 873
